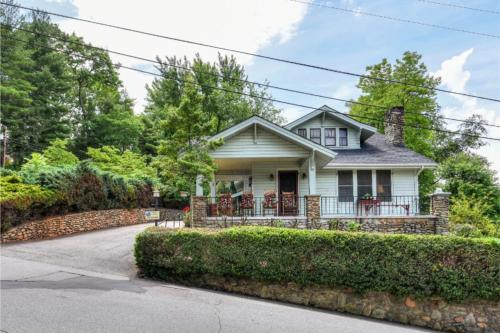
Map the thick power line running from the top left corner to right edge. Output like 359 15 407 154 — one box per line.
0 2 500 102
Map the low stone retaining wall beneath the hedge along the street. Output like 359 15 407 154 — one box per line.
170 275 500 333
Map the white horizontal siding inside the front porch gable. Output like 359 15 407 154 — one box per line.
210 128 309 158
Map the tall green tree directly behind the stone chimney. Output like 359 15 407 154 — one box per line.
349 52 440 158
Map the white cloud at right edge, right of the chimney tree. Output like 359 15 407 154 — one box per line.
434 48 500 175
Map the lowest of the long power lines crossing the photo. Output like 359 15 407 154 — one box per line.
7 37 500 141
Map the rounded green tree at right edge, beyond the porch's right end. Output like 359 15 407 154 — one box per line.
438 153 500 222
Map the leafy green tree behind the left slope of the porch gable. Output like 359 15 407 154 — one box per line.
141 55 284 155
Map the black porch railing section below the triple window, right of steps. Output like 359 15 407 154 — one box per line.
321 195 429 216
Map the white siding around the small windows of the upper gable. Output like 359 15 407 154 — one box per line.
292 115 360 149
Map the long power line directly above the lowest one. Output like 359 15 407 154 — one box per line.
17 28 500 128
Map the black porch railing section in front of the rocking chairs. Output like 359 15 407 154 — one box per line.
207 196 306 217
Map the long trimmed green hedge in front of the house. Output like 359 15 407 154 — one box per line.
135 227 500 301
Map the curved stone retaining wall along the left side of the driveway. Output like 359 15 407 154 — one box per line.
1 208 180 243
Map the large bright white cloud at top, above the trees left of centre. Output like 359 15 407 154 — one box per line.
59 0 307 112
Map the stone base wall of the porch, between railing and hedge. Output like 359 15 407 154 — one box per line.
201 216 439 234
